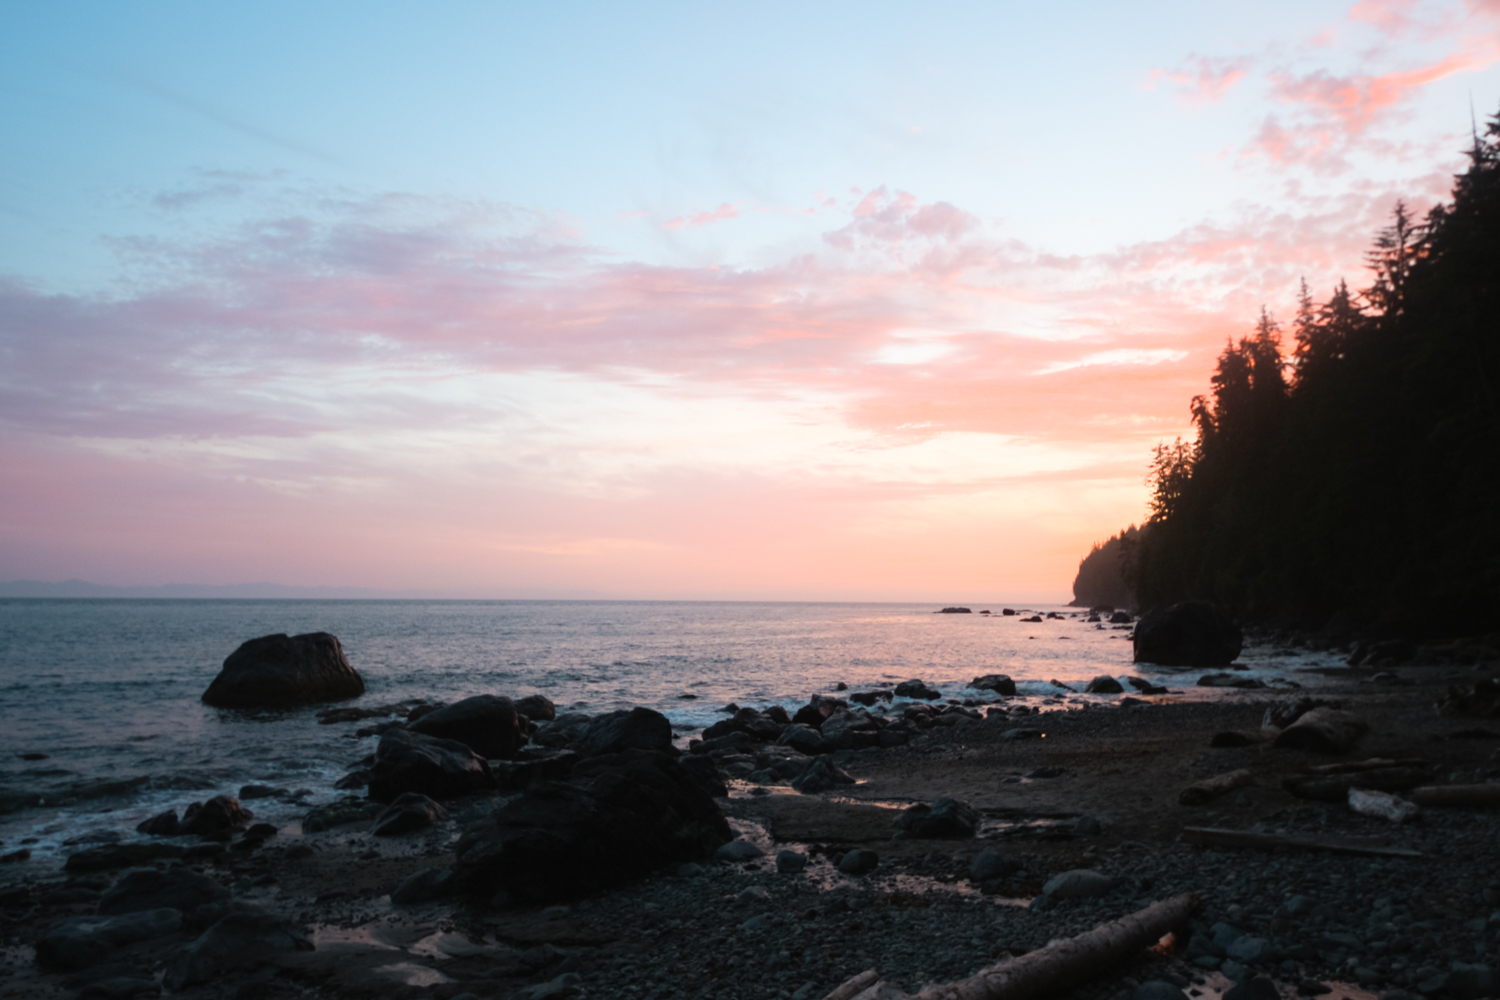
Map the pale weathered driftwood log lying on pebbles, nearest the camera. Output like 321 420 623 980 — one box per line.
825 892 1199 1000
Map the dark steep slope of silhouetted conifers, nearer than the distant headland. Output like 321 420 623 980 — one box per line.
1127 115 1500 631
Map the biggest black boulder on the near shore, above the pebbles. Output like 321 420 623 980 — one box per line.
455 750 732 903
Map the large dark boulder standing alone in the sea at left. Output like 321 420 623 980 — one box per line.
203 633 365 708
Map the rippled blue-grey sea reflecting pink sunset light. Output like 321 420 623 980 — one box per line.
0 600 1338 862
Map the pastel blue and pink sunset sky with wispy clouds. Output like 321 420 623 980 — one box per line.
0 0 1500 603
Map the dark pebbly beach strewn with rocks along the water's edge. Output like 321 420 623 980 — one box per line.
0 632 1500 1000
